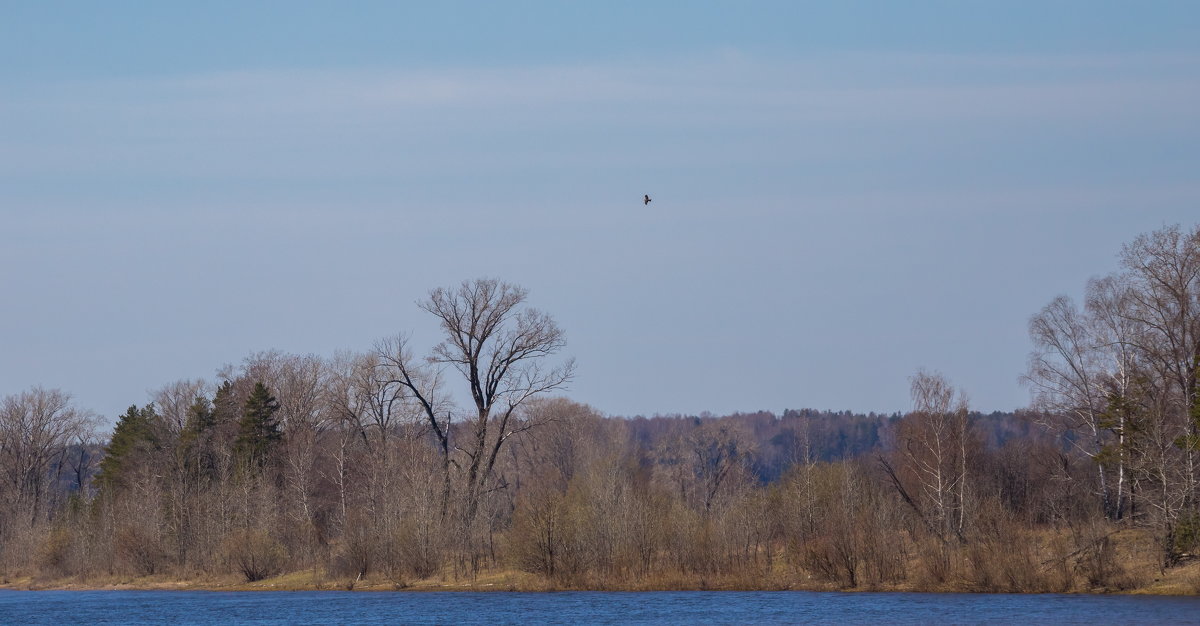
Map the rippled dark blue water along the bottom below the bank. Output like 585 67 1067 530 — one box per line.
0 590 1200 626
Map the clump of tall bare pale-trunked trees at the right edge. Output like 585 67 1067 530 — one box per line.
1024 227 1200 526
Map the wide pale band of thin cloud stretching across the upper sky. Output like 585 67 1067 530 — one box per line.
0 50 1200 187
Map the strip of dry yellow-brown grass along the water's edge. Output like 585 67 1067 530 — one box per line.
0 529 1200 595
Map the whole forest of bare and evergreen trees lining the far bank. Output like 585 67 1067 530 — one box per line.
7 225 1200 594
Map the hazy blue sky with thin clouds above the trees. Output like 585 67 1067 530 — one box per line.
0 1 1200 420
